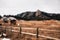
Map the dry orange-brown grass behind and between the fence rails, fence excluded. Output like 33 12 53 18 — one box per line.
1 20 60 40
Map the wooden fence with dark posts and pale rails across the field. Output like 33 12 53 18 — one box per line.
2 27 60 40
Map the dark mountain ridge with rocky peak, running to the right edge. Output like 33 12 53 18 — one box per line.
14 10 60 20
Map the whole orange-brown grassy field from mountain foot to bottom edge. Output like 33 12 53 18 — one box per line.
0 20 60 40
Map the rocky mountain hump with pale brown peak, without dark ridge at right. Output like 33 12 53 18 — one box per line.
16 10 51 20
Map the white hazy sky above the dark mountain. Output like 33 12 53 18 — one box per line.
0 0 60 15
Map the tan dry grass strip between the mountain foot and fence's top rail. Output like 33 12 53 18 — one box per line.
17 20 60 30
